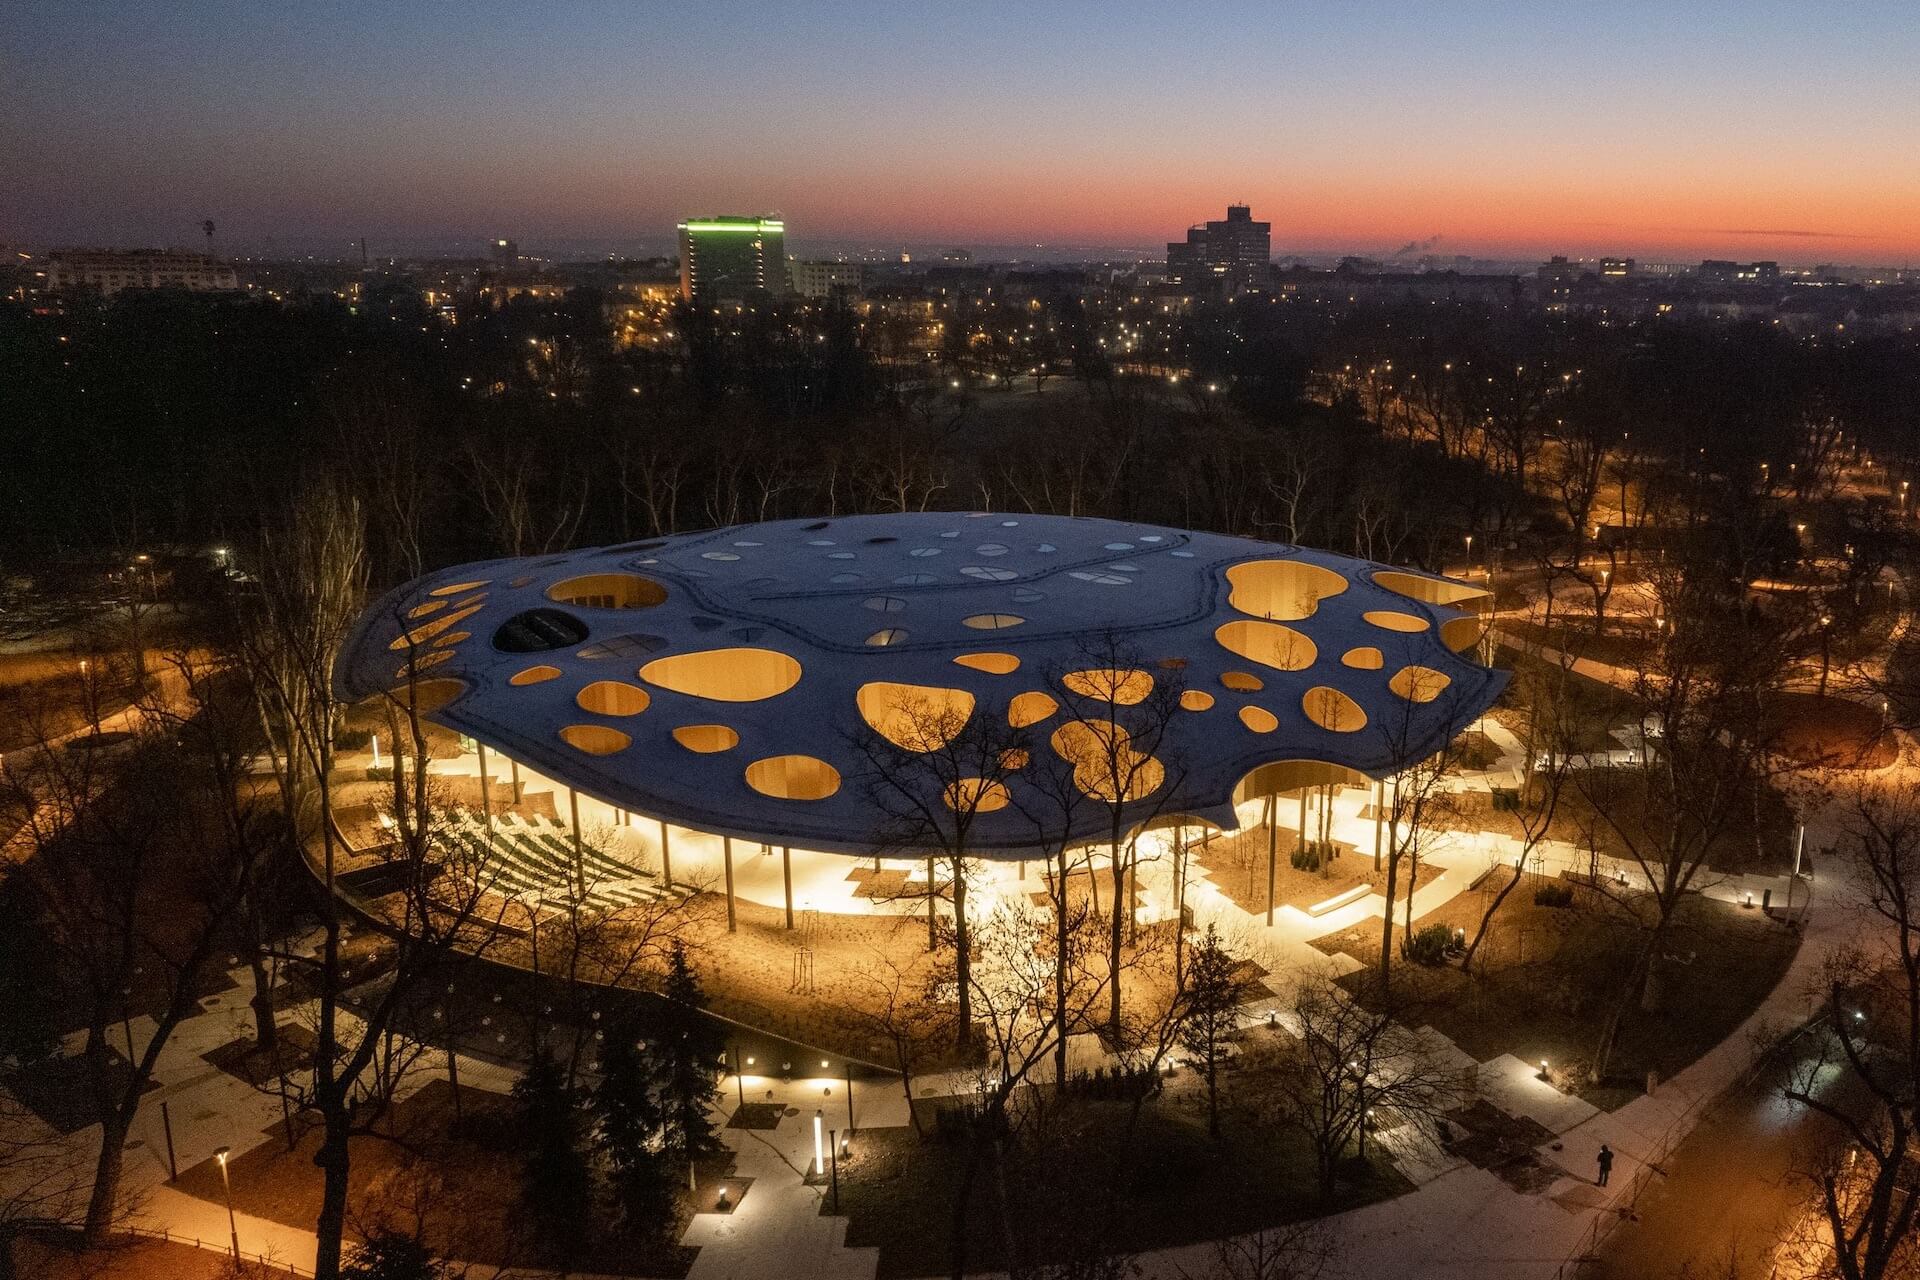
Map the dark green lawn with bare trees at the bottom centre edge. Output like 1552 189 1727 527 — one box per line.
822 1073 1409 1278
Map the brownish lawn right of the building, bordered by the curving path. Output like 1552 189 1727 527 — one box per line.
1315 873 1799 1107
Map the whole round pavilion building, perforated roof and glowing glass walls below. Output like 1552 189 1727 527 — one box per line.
336 512 1505 927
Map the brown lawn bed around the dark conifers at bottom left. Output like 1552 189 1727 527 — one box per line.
175 1080 698 1276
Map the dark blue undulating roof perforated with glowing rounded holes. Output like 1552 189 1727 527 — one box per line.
336 512 1505 858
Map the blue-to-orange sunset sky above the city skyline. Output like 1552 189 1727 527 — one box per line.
0 0 1920 263
